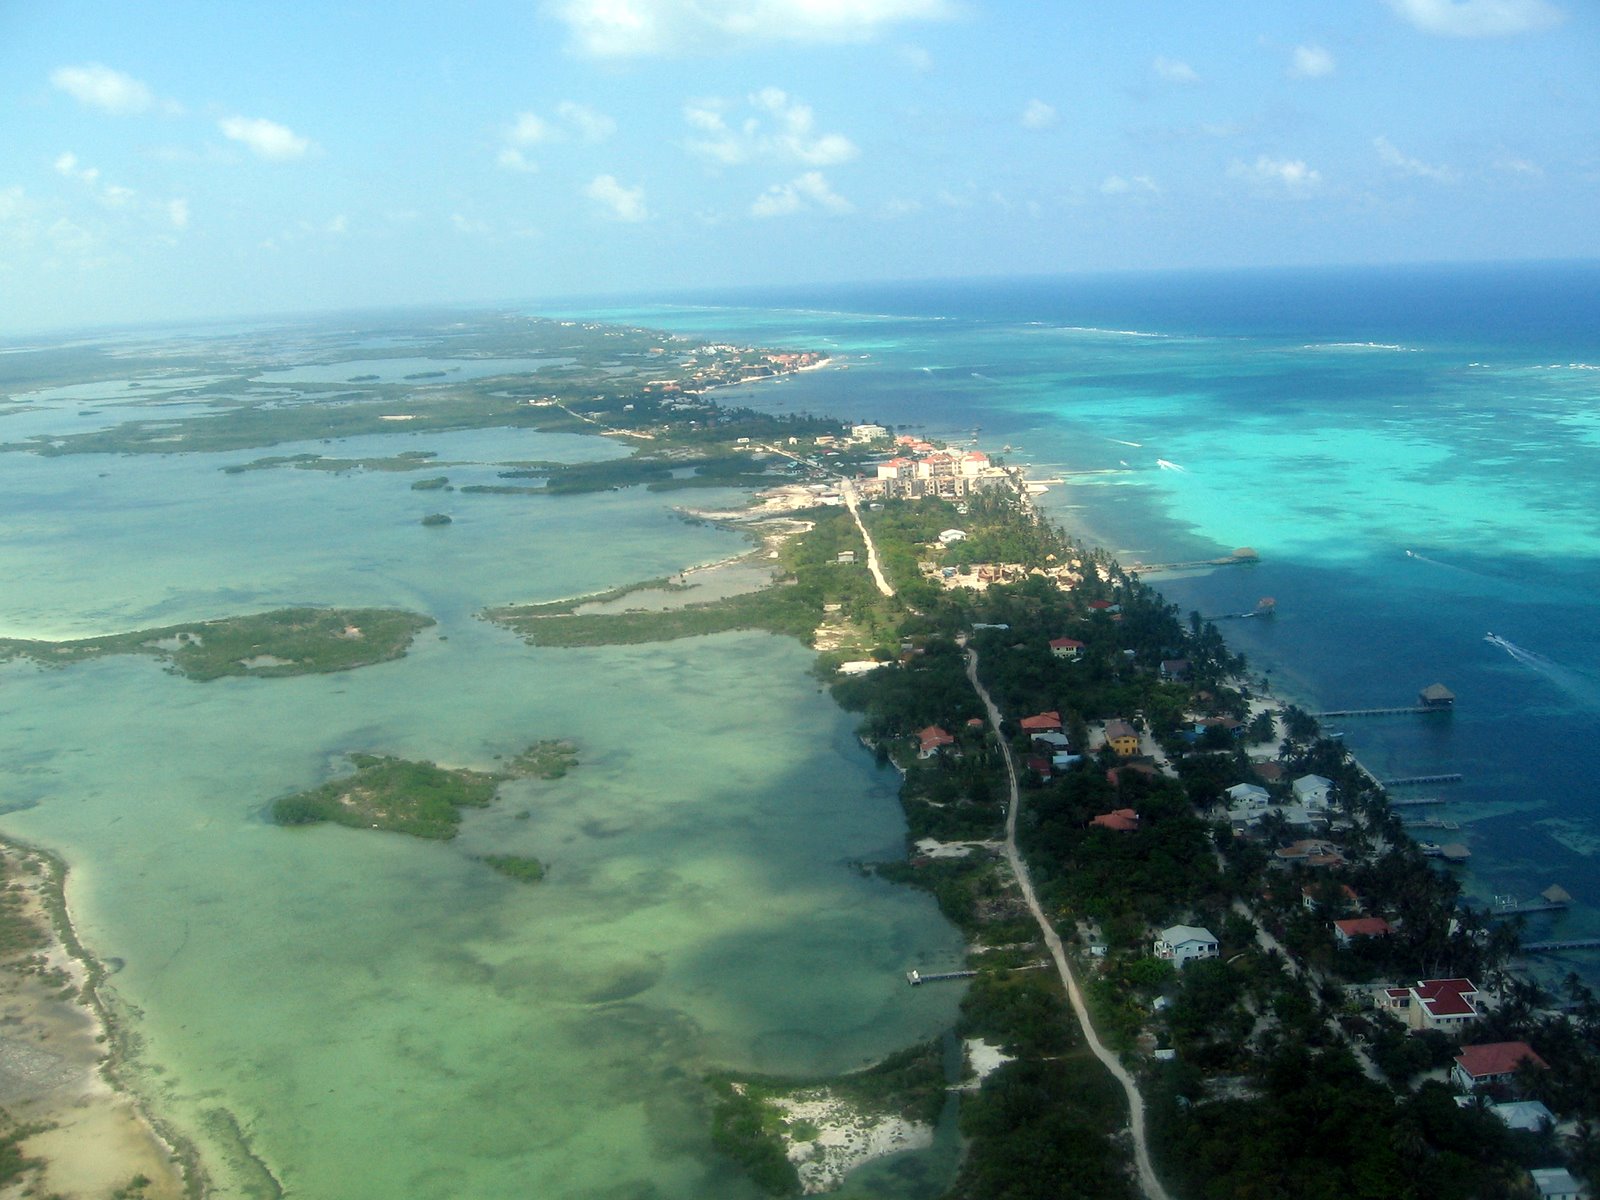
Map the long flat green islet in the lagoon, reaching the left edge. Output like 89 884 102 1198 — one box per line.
0 608 434 682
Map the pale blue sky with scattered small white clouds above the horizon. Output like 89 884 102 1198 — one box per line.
0 0 1600 334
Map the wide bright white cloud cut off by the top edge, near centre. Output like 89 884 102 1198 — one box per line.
544 0 957 58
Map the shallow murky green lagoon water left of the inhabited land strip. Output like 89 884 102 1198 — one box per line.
0 419 960 1200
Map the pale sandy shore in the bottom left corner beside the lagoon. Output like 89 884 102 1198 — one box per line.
0 842 198 1200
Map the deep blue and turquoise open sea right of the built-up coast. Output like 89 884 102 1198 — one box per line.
560 262 1600 981
